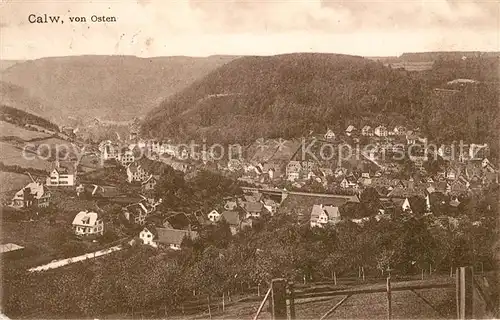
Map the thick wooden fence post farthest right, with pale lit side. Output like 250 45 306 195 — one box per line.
456 267 474 319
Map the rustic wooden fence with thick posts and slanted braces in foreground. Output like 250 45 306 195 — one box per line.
253 267 498 320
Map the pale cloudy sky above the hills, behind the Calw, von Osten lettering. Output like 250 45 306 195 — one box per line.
0 0 500 60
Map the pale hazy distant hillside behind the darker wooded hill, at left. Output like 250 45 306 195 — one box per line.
1 56 238 124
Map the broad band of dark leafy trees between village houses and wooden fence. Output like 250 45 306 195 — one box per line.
3 208 494 317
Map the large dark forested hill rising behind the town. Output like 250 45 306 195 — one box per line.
143 53 498 148
